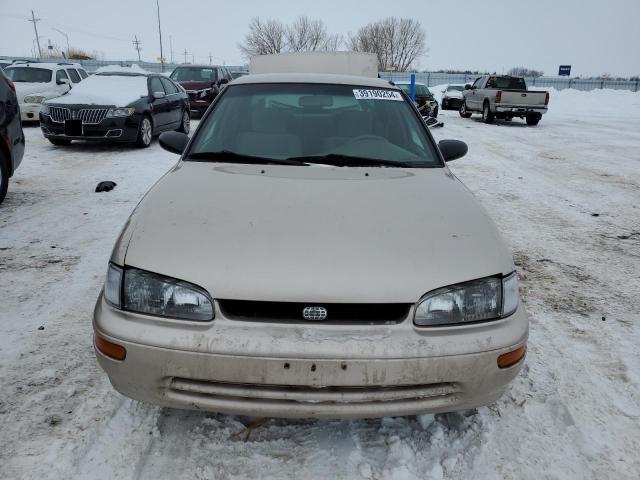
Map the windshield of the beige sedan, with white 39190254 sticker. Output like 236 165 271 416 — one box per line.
185 84 442 167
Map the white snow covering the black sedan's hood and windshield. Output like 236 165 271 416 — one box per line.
51 75 149 107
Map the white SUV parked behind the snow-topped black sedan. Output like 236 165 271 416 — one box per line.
4 63 88 121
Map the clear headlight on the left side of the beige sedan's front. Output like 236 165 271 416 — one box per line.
104 264 214 322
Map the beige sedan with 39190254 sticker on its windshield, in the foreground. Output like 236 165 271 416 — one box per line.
94 74 528 418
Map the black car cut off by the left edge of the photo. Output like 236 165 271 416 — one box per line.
0 70 24 203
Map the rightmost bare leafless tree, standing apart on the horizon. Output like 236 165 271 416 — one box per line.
348 17 427 72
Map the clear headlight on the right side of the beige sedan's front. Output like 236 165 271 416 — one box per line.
414 272 518 327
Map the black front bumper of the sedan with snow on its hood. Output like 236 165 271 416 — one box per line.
40 114 139 142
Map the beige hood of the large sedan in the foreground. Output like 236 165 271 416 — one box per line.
119 162 514 303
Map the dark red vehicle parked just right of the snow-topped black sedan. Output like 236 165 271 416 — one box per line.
170 65 233 114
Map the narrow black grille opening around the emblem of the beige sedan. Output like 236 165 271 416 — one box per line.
218 299 412 323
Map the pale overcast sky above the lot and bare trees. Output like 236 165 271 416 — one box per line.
0 0 640 76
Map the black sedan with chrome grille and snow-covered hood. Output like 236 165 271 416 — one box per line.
40 72 191 147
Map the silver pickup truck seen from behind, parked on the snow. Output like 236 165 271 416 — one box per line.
460 75 549 125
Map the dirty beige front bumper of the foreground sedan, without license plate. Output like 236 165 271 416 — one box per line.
94 295 528 418
